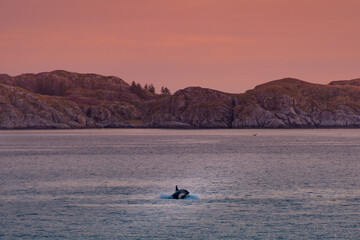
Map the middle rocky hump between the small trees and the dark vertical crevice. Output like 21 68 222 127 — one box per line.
143 87 233 128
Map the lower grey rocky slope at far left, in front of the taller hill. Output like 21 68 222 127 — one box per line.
0 84 91 129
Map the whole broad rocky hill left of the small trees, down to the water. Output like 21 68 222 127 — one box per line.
0 70 146 129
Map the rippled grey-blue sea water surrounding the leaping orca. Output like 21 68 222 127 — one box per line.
0 129 360 239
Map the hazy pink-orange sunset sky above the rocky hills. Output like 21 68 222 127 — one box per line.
0 0 360 93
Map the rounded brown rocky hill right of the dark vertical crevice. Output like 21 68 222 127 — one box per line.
233 78 360 128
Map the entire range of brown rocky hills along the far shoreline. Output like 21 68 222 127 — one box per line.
0 70 360 129
